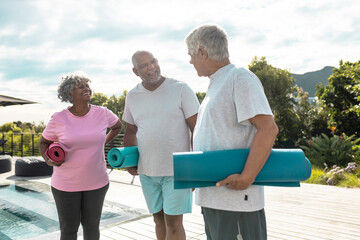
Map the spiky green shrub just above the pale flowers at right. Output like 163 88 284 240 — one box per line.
301 134 360 167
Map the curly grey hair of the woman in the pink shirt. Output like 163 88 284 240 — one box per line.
58 74 91 103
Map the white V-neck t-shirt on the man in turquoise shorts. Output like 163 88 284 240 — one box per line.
123 78 199 176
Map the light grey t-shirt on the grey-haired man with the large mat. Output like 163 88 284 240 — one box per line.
193 64 272 212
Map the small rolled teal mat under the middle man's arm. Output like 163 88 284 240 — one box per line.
107 146 139 168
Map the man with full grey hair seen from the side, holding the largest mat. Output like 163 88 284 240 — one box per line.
186 25 278 240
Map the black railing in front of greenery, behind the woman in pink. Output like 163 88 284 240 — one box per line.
0 133 124 162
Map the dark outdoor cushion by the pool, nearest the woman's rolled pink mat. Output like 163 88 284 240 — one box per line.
15 157 53 177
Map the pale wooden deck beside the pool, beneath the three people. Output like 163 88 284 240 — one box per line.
0 158 360 240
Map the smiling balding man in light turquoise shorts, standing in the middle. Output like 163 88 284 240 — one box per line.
123 51 199 240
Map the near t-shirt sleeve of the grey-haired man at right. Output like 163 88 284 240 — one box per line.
233 71 272 125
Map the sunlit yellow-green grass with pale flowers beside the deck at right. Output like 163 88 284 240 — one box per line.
304 166 360 188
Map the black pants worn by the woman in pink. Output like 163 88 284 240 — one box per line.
51 184 109 240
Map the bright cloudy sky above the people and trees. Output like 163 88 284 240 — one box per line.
0 0 360 125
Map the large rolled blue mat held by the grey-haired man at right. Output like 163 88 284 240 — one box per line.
173 149 311 189
